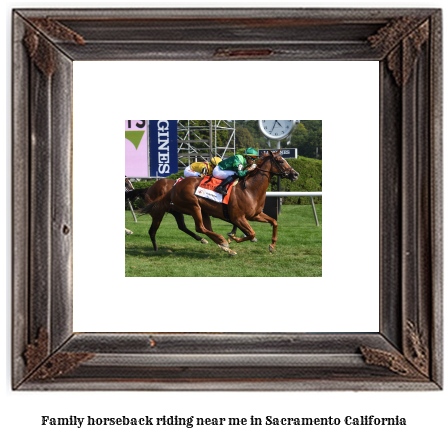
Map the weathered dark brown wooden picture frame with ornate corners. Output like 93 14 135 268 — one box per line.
12 9 442 390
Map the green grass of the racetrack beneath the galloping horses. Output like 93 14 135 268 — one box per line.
125 205 322 277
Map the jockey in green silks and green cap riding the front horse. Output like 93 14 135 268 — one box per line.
213 148 258 196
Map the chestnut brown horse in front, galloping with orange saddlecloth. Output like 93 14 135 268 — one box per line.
142 151 299 255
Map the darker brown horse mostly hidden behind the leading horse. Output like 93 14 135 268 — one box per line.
125 178 240 251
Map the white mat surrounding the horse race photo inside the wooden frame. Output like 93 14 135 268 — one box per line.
73 61 379 332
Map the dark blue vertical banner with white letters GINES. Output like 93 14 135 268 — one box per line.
149 120 178 178
